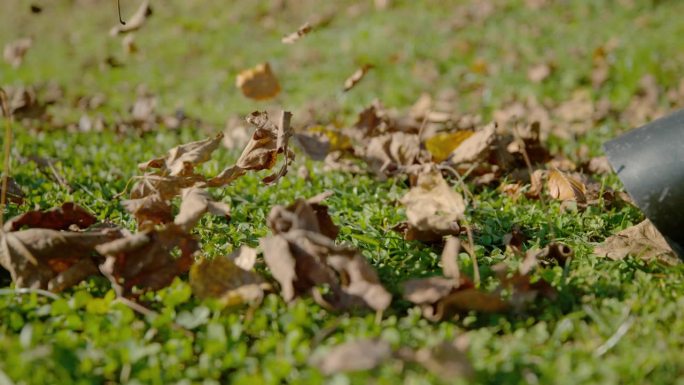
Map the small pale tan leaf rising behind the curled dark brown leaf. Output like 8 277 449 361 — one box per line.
173 187 230 232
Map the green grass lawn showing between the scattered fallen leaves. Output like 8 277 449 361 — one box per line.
0 0 684 384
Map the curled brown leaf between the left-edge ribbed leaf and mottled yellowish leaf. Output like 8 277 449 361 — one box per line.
96 223 198 297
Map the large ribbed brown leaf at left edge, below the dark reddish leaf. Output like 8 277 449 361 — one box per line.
0 228 121 292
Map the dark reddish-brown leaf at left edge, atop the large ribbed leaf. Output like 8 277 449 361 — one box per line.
3 202 97 232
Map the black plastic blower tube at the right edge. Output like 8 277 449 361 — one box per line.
603 110 684 259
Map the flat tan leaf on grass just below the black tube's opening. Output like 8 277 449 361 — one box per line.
594 219 679 264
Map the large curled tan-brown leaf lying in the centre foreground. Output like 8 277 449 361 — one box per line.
261 230 392 311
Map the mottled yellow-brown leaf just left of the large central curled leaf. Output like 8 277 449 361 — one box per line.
190 246 270 306
